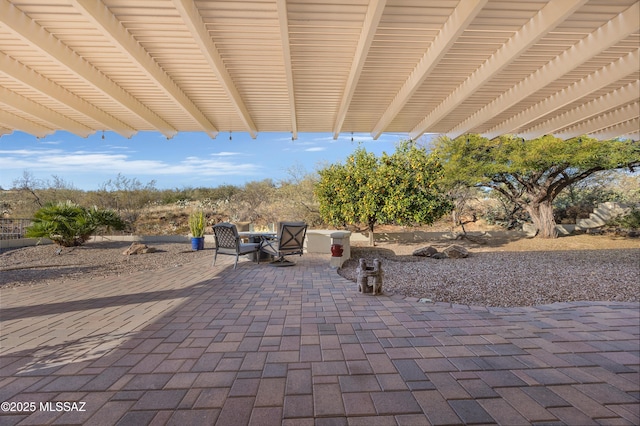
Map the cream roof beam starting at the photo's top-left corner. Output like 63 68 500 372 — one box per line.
0 0 177 138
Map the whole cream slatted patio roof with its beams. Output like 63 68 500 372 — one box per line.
0 0 640 139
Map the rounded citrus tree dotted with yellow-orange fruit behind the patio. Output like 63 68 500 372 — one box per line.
314 141 451 245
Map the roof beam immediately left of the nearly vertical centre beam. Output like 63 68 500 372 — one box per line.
173 0 258 139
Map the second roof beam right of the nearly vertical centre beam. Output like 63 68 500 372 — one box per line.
371 0 487 139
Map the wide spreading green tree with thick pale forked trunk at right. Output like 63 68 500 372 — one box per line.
435 135 640 238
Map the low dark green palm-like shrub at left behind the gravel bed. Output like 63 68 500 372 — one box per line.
26 201 126 247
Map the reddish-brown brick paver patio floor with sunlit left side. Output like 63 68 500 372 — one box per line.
0 251 640 426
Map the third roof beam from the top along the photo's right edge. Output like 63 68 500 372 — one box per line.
518 81 640 139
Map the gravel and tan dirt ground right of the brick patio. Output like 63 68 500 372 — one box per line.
339 235 640 307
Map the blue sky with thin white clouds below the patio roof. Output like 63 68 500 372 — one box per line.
0 132 408 190
